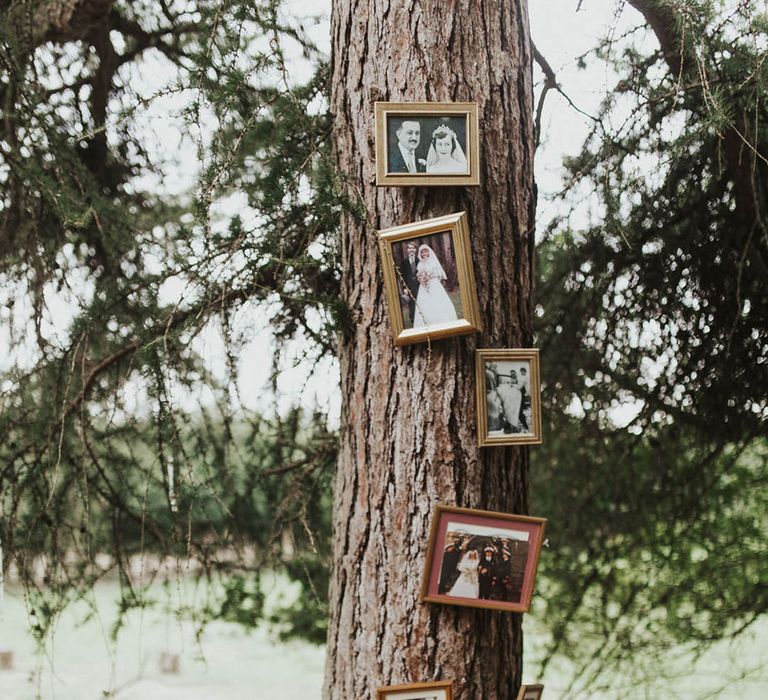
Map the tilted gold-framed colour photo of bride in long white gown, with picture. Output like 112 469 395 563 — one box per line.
378 212 482 345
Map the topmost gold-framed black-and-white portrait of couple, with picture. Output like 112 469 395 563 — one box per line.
374 102 480 187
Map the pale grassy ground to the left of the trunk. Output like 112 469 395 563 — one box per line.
0 583 324 700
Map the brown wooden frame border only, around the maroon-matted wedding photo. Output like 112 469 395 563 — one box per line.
419 505 547 612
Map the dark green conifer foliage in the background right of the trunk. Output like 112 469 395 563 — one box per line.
533 1 768 697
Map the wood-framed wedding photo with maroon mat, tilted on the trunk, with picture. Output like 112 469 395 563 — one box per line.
420 505 547 612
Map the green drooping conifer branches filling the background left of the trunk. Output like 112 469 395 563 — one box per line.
0 0 340 640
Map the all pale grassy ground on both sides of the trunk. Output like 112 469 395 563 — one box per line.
0 581 768 700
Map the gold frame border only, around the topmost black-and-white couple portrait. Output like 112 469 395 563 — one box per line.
373 102 480 187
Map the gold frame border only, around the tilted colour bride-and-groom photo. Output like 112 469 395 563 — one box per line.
378 211 483 345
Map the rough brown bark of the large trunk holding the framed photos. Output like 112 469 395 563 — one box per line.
325 0 535 700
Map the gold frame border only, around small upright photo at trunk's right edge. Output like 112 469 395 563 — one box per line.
475 348 542 447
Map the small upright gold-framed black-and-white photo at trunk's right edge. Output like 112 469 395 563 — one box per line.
475 348 542 447
